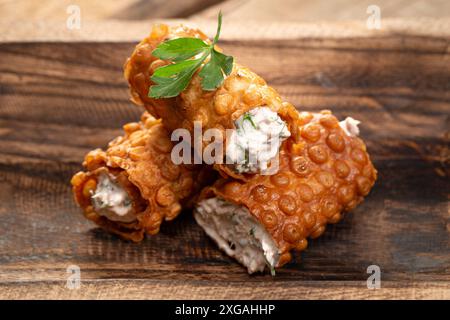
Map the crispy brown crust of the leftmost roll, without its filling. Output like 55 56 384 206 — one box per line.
71 113 208 242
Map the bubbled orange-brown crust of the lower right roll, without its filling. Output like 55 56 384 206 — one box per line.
200 111 377 266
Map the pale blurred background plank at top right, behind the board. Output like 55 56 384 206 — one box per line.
195 0 450 23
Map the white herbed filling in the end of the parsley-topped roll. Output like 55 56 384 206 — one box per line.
226 107 291 173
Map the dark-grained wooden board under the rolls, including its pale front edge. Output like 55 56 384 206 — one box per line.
0 21 450 299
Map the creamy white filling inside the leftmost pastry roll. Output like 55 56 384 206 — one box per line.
91 173 135 222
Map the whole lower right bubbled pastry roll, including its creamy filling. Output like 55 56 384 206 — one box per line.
194 111 377 273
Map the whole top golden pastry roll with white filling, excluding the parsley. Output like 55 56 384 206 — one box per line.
124 25 298 180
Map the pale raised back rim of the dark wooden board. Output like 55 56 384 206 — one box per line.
0 16 450 42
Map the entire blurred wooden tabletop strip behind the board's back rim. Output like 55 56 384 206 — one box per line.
0 0 450 24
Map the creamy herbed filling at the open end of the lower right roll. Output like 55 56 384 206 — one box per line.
194 198 279 273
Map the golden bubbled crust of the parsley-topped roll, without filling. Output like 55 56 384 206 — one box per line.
125 25 298 180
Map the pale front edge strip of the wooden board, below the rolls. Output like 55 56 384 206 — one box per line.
0 279 450 300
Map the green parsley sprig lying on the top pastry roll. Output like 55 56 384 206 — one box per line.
148 12 233 99
